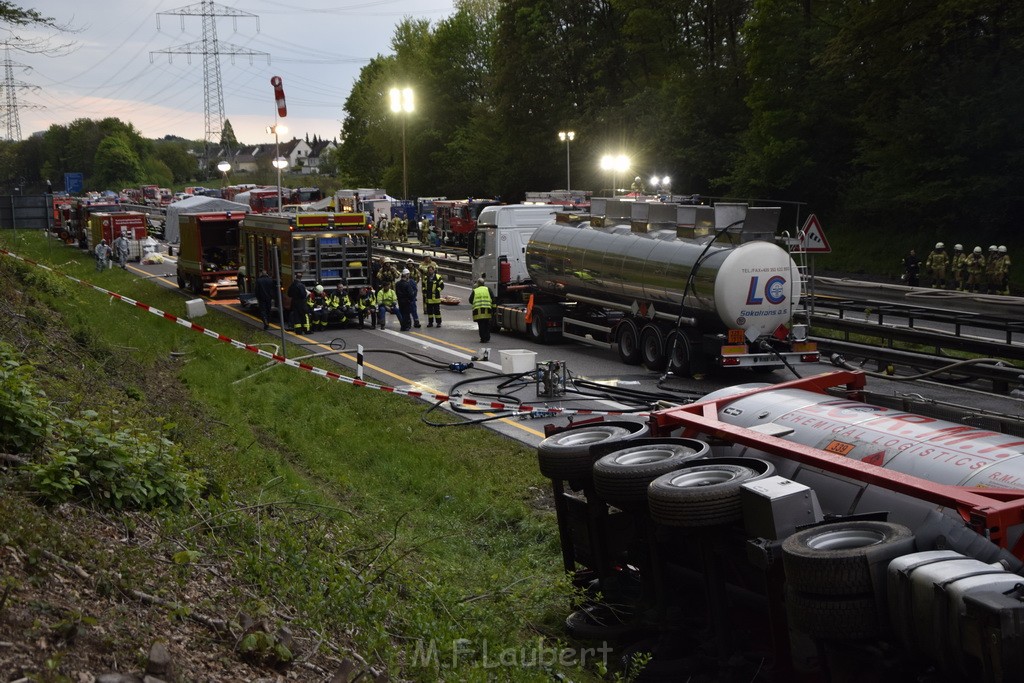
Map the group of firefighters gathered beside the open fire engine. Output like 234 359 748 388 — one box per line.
280 256 444 333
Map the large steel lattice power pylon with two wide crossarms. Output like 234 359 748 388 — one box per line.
150 0 270 169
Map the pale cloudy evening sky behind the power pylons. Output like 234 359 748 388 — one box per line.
8 0 455 144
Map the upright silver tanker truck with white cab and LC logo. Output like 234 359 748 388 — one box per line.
471 199 819 375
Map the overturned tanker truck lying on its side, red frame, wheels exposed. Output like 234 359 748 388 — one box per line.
538 372 1024 683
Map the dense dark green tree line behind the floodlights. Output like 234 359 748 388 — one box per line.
337 0 1024 253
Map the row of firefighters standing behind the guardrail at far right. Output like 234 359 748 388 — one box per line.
903 242 1010 294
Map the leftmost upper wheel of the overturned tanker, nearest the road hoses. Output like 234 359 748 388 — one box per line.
537 421 649 481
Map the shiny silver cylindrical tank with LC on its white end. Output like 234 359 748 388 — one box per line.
526 221 802 340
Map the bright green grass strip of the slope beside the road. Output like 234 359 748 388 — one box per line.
0 232 596 680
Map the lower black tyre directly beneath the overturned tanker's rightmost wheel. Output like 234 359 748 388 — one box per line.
785 588 882 640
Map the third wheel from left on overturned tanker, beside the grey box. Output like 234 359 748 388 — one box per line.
647 458 774 528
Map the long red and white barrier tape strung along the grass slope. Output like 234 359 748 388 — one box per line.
0 248 643 417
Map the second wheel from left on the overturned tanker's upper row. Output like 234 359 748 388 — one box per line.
594 439 709 508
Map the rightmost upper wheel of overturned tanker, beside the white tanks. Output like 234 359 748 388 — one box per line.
782 520 914 597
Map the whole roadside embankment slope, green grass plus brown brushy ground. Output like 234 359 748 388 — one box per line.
0 232 591 680
